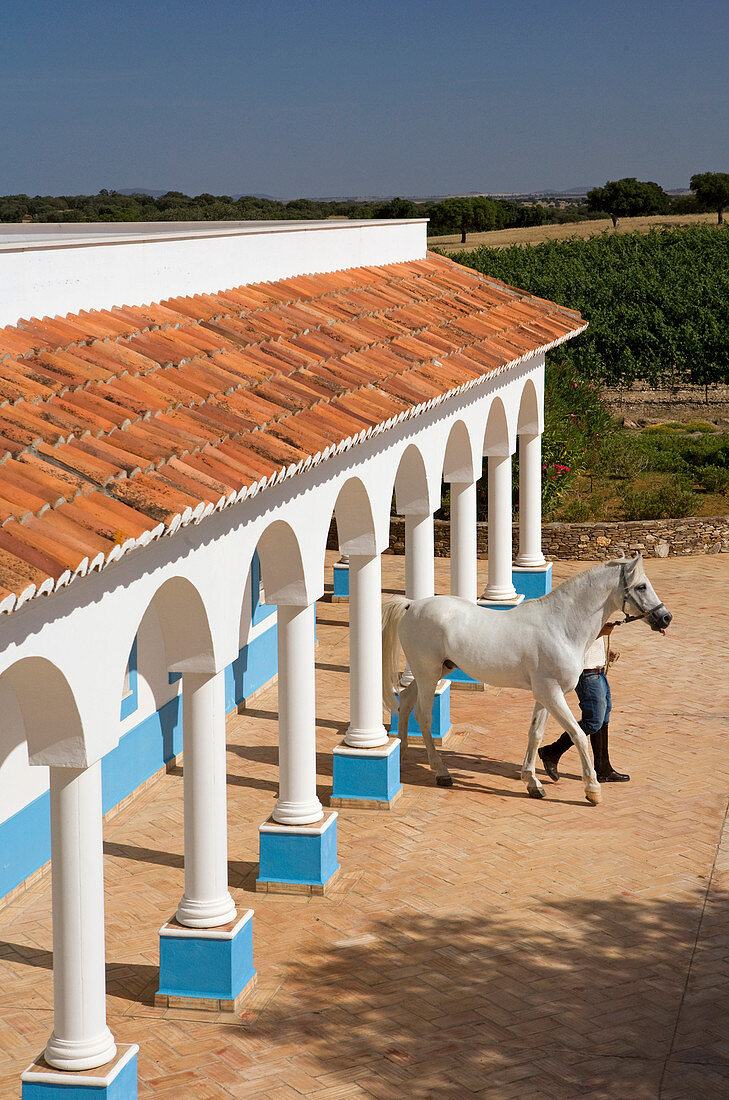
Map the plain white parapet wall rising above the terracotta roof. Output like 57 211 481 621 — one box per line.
0 219 428 325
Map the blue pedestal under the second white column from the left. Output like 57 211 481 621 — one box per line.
154 909 256 1012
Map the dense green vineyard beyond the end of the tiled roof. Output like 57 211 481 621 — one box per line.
453 226 729 387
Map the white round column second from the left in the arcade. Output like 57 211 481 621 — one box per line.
176 672 235 928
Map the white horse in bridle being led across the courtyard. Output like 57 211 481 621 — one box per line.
383 554 672 805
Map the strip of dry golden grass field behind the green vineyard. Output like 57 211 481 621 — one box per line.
428 213 717 252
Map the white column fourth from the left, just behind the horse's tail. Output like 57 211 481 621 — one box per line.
344 554 388 748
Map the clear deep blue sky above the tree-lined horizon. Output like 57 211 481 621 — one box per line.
0 0 729 198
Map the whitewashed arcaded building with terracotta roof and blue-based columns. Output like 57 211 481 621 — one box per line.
0 221 585 1100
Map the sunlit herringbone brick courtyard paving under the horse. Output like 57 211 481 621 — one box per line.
0 556 729 1100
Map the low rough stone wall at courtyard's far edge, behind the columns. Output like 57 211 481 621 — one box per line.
329 516 729 561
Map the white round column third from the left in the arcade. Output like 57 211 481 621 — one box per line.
273 603 324 825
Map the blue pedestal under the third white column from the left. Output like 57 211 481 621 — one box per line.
256 811 340 897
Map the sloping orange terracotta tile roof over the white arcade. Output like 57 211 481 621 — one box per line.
0 248 585 611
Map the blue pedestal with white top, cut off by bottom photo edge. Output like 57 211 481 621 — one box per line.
20 1043 140 1100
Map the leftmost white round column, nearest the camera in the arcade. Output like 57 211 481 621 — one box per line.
45 760 117 1070
